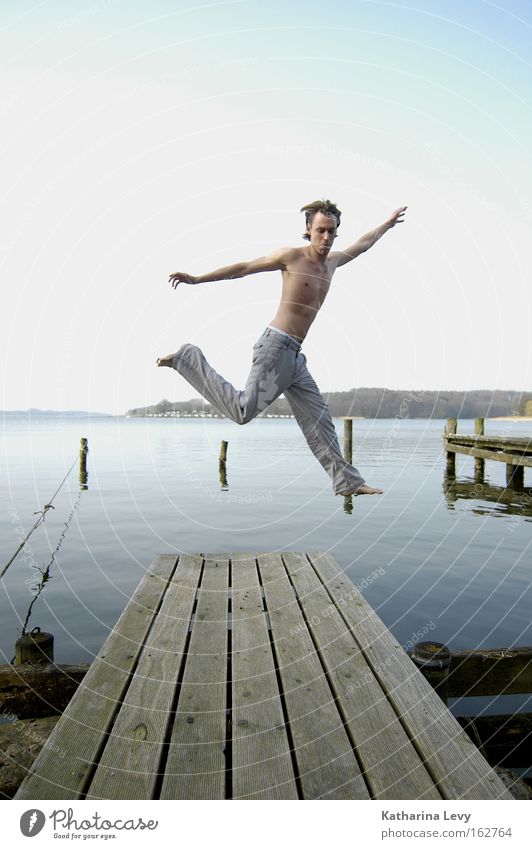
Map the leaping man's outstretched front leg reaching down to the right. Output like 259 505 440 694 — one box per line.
284 353 381 495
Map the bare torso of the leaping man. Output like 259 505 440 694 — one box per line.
270 247 337 341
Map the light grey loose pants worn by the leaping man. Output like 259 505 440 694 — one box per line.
173 328 364 495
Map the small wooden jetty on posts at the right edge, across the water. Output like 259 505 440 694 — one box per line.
443 418 532 491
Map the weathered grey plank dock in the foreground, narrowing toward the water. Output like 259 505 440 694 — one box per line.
16 553 511 800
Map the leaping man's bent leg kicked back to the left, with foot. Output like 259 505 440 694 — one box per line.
158 333 296 424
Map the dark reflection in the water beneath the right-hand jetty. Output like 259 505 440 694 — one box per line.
443 475 532 518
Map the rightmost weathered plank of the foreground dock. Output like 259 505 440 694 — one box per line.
311 554 511 799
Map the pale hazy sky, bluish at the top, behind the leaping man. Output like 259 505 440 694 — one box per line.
0 0 532 413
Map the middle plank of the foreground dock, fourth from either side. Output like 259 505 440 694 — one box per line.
231 554 298 799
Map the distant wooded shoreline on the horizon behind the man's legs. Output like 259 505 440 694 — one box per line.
126 387 532 419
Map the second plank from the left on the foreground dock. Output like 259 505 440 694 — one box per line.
86 555 201 799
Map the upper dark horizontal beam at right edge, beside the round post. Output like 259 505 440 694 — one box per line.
448 646 532 698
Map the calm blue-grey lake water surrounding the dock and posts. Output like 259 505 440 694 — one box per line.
0 416 532 712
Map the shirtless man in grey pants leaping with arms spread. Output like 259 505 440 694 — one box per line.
157 200 406 496
